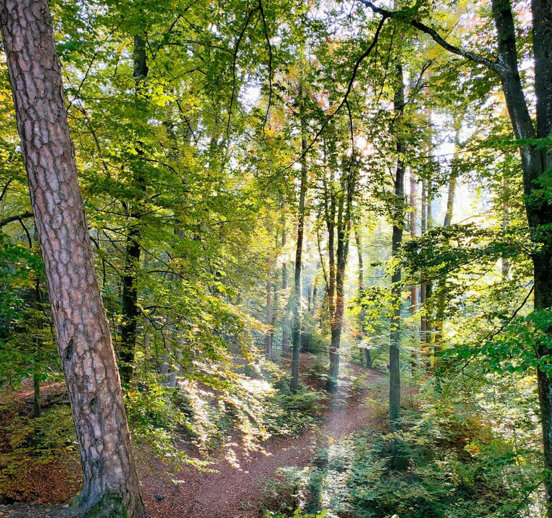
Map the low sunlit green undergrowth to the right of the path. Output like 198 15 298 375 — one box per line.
265 402 540 518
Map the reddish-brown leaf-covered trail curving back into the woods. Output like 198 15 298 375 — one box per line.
140 355 385 518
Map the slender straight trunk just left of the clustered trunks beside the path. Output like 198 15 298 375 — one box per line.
291 83 307 392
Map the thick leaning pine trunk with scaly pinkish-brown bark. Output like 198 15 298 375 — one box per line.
0 0 146 518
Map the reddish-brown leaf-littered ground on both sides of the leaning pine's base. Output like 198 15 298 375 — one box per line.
0 354 385 518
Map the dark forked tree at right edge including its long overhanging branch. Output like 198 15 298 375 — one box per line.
361 0 552 517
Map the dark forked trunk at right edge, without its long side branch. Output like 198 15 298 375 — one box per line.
492 0 552 518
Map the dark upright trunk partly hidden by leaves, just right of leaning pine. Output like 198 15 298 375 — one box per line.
119 36 148 383
